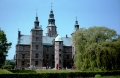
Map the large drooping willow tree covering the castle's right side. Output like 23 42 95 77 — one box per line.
73 26 120 70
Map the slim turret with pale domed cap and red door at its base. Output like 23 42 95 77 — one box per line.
55 35 63 69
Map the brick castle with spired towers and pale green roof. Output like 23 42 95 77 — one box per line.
15 9 79 69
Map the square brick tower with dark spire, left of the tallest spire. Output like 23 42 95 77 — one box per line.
30 14 43 67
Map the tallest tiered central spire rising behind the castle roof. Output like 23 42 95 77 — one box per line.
46 5 57 37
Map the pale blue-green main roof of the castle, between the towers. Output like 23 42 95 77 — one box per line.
18 35 72 46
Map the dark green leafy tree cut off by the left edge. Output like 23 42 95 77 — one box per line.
0 29 12 68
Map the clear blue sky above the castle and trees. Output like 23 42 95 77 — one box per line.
0 0 120 59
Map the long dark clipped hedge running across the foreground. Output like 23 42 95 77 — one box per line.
0 70 120 78
